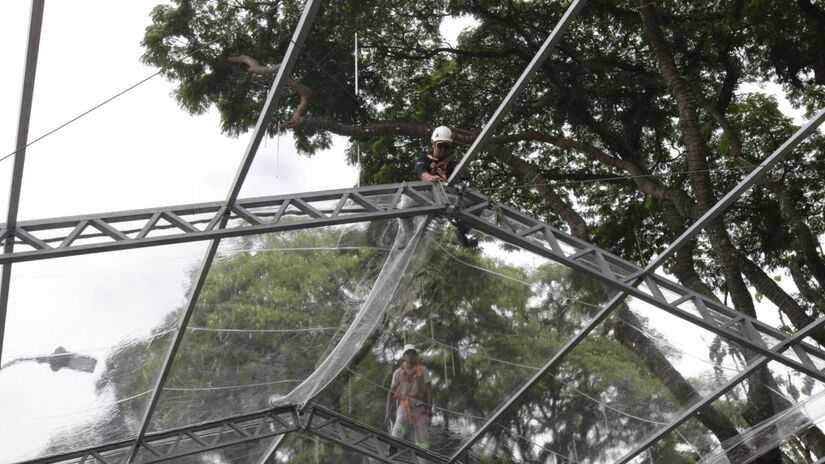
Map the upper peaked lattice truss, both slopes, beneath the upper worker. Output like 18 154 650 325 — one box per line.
0 182 825 381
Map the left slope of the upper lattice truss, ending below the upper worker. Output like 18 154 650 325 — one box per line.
0 182 448 265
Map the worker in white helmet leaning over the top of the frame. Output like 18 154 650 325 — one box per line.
415 126 478 248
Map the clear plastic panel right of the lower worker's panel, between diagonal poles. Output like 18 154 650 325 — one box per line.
472 308 682 463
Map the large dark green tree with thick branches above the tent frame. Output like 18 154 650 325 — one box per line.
132 0 825 462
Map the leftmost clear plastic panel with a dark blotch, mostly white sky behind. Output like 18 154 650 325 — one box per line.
0 244 204 462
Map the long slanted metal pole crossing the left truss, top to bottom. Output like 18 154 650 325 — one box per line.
126 0 320 463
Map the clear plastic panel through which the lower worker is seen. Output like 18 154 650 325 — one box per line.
308 220 605 456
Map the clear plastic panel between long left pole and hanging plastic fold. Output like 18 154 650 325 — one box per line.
150 221 408 431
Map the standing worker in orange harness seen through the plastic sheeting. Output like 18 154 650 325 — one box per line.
384 344 433 462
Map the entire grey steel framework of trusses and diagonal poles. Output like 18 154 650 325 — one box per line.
0 0 825 464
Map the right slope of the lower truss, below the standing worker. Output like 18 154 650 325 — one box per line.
304 404 447 464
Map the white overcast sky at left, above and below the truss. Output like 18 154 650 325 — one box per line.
0 0 356 456
